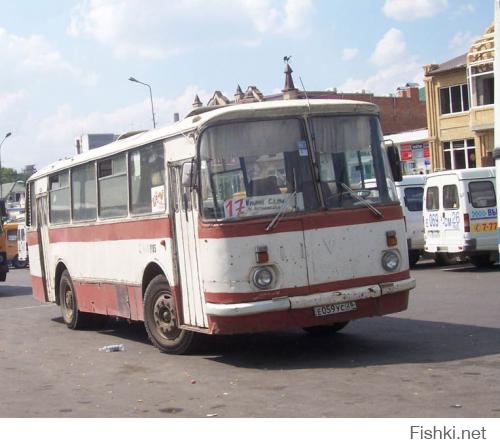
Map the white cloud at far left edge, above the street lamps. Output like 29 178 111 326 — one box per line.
0 28 96 84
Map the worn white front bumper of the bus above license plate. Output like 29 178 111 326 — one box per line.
206 278 416 317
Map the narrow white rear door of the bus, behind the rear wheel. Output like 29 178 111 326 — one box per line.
36 193 55 302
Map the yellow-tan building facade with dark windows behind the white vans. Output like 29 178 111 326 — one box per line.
424 25 495 171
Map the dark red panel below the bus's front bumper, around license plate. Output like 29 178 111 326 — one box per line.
208 291 409 334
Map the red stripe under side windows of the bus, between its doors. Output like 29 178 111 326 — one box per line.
49 218 172 243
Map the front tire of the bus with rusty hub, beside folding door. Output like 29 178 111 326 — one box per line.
144 275 198 355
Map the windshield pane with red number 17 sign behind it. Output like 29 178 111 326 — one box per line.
200 119 319 219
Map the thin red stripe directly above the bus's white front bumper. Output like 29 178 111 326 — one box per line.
205 270 410 304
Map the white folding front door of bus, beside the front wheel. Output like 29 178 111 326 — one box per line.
169 160 208 328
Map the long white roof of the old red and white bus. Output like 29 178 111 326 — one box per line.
29 100 378 181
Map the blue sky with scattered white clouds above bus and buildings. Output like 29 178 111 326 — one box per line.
0 0 494 171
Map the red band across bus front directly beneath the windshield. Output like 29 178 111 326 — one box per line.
198 205 403 239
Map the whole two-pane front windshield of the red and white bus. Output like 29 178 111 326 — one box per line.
200 116 396 220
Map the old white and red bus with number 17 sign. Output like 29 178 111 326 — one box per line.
27 100 415 353
